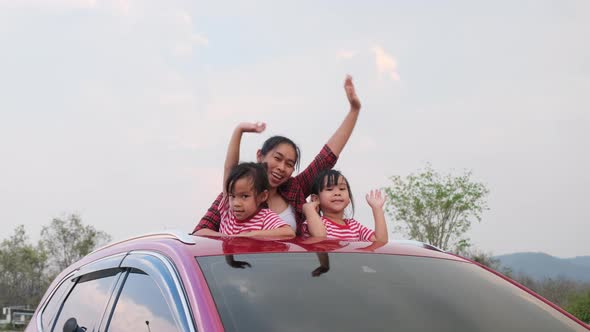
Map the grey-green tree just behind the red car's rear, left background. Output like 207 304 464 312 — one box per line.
41 214 111 271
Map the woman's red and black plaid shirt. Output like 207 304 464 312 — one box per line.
193 145 338 233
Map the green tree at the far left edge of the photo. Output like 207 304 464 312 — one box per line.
0 225 49 307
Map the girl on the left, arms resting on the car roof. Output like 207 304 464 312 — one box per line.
196 163 295 237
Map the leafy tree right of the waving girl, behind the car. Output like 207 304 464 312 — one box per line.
385 165 489 250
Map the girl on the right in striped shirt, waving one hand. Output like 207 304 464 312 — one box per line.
303 170 388 242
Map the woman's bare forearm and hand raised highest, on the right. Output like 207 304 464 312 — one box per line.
326 75 361 156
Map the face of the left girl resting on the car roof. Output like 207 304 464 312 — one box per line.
229 177 268 220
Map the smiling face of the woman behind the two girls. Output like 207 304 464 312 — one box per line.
257 143 297 188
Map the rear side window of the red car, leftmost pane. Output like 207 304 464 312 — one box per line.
53 269 119 331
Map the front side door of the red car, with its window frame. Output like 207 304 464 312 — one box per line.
100 251 196 332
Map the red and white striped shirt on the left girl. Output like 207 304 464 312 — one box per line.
219 196 288 235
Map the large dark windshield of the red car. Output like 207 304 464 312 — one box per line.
197 253 585 332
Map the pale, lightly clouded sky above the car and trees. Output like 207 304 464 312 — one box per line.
0 0 590 257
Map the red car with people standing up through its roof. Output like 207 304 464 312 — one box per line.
26 231 590 332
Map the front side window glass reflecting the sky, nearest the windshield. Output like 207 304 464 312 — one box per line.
108 270 179 332
